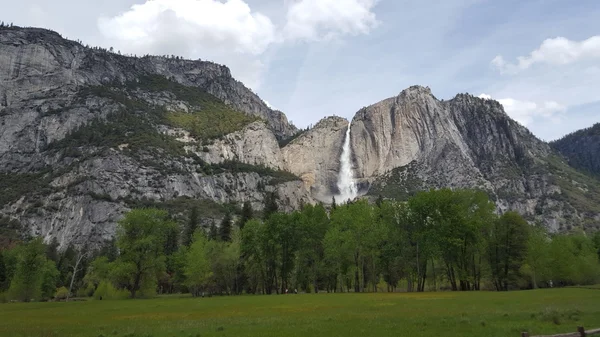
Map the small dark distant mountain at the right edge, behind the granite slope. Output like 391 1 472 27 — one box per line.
550 123 600 177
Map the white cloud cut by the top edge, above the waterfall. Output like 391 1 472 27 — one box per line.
283 0 378 41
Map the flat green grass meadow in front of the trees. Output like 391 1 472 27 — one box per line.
0 288 600 337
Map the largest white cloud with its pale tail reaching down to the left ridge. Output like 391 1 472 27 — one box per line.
98 0 276 89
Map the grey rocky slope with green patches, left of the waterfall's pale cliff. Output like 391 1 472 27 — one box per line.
0 28 312 247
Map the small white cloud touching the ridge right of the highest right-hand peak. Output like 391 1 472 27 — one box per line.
479 94 566 126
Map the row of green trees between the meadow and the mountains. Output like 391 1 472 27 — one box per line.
0 189 600 301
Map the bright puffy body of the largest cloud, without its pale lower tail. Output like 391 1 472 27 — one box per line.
99 0 275 55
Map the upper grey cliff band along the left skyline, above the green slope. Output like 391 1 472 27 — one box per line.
0 28 296 138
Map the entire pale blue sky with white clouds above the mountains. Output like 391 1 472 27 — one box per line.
0 0 600 140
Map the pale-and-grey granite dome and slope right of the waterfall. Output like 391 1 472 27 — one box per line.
352 86 600 230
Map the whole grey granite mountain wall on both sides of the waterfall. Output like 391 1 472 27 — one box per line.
0 27 600 247
